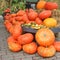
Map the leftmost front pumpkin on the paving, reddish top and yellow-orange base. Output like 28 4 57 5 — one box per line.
7 36 22 52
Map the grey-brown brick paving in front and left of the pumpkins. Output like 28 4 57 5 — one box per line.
0 17 60 60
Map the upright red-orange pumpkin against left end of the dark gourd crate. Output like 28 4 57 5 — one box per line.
12 24 22 39
